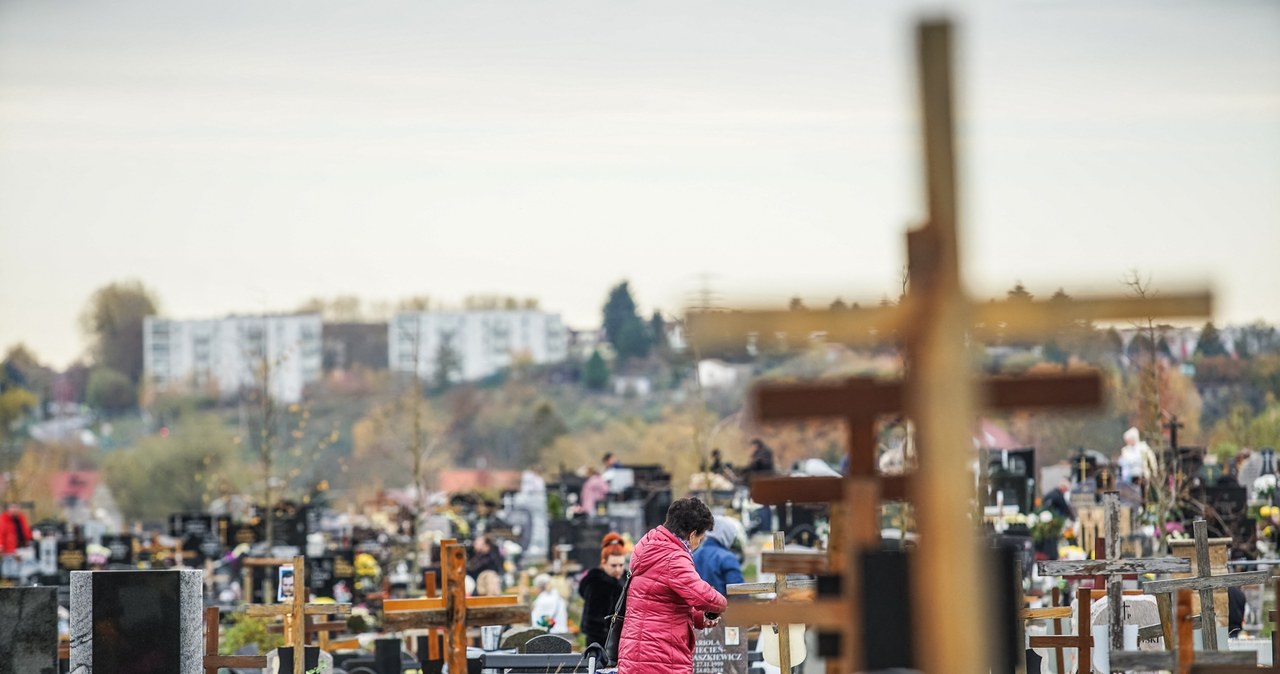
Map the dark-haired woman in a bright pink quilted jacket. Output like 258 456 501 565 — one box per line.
618 499 726 674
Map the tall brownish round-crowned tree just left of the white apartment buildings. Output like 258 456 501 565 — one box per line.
79 280 157 385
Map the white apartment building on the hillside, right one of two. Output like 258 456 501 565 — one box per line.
387 310 568 381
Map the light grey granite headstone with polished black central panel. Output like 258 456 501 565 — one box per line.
70 569 205 674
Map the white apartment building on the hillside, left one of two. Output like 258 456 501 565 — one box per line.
142 313 323 403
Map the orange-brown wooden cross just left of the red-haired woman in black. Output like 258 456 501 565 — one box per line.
383 544 531 671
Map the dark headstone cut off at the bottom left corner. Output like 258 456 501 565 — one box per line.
0 587 58 674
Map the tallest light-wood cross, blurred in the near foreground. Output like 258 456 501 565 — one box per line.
686 20 1211 674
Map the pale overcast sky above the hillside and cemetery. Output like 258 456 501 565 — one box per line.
0 0 1280 366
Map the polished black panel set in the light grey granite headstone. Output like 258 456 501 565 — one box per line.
91 572 182 674
